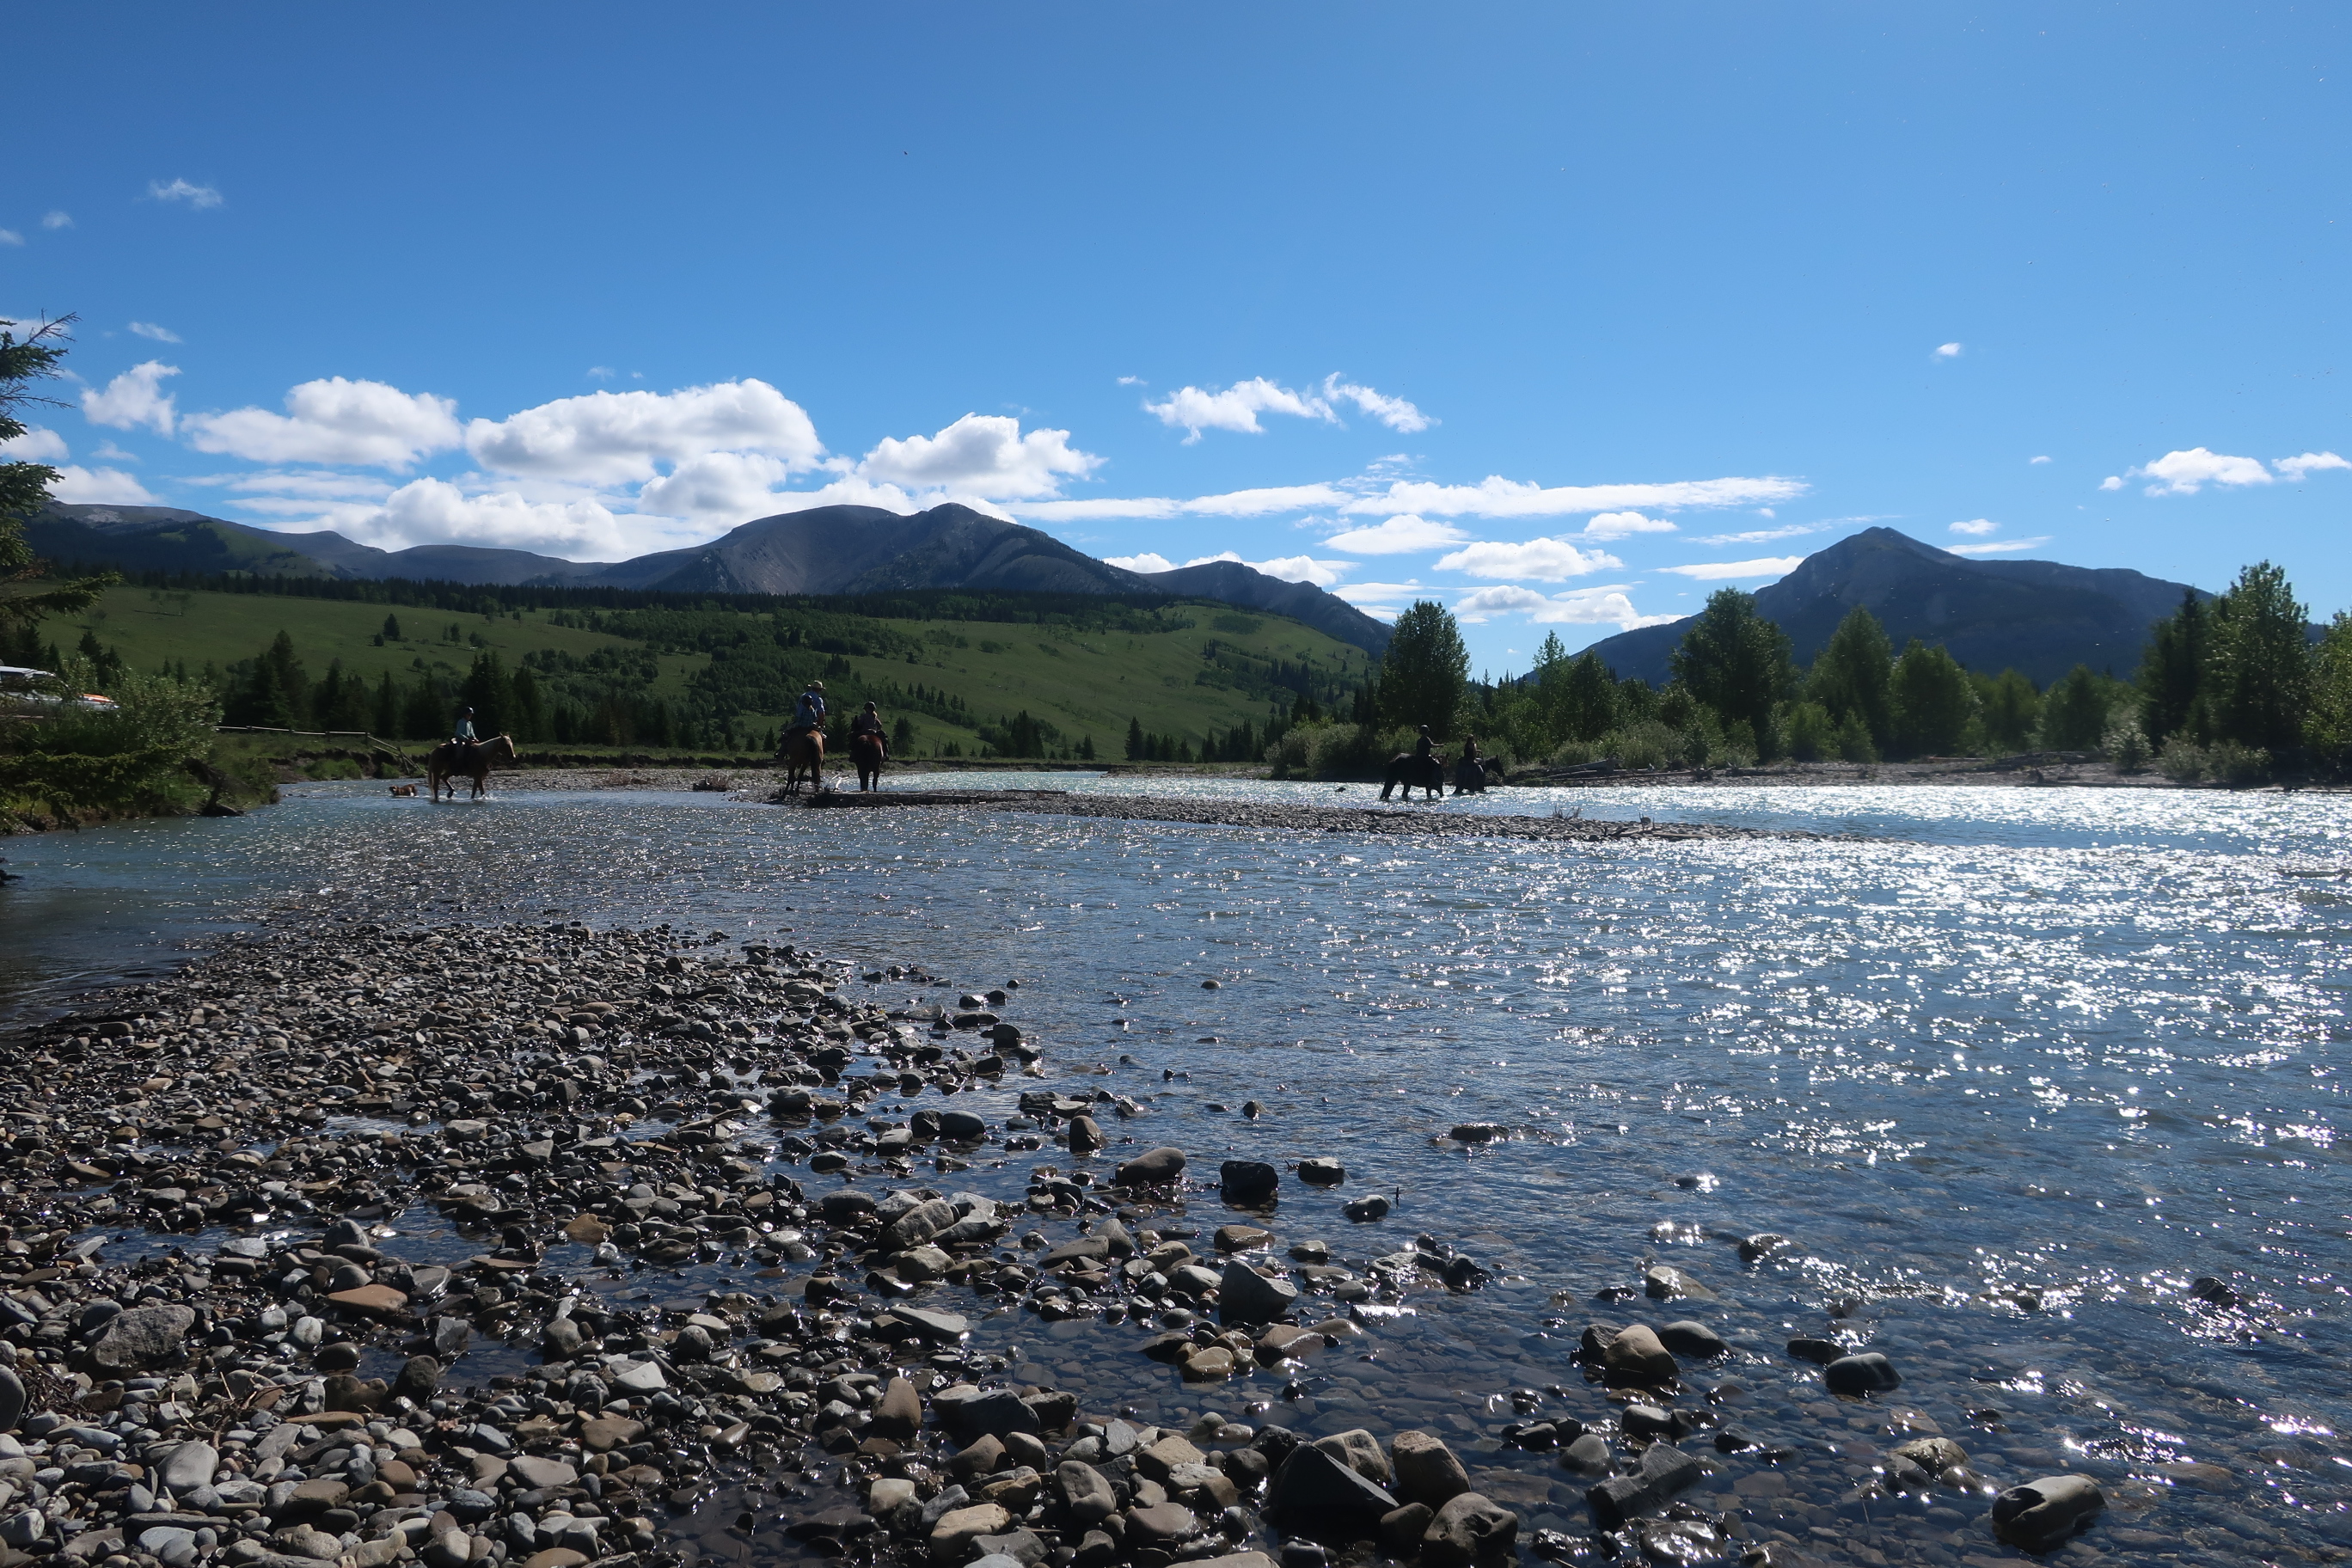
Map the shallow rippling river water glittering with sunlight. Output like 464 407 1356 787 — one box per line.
0 775 2352 1561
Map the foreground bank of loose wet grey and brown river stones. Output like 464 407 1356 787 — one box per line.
0 921 2145 1568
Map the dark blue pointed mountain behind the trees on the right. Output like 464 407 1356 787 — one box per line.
1592 529 2211 687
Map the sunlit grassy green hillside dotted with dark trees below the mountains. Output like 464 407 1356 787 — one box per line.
42 585 1367 759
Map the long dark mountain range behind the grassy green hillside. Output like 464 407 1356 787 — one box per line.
26 503 1387 656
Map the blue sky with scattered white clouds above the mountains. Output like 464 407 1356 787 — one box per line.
0 4 2352 670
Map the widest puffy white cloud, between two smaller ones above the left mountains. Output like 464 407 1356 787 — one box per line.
466 378 825 487
